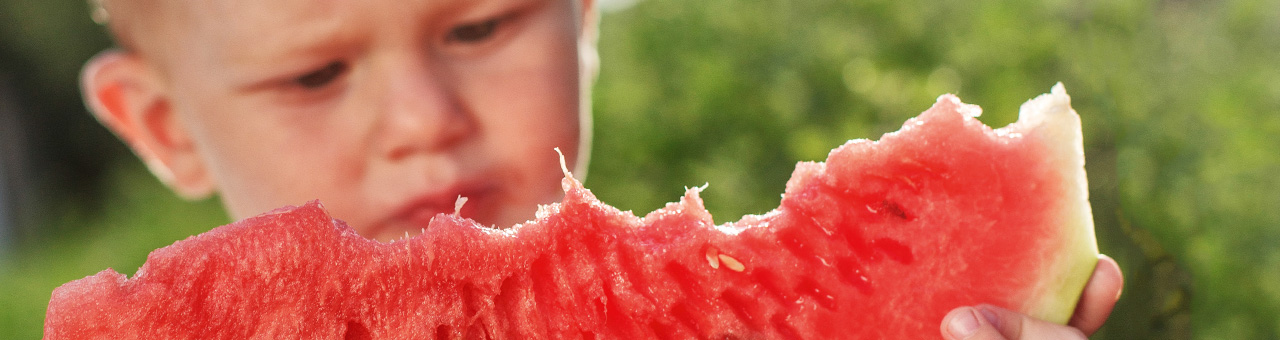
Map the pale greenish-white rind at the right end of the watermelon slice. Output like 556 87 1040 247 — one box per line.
1009 83 1098 325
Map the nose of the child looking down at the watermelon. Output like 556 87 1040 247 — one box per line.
381 61 477 160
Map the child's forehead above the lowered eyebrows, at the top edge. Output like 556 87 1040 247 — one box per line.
133 0 573 83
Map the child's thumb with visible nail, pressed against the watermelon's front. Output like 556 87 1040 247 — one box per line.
942 304 1087 340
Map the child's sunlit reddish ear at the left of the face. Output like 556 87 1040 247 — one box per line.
81 50 214 199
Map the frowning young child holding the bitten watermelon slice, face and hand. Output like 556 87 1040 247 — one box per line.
82 0 1119 339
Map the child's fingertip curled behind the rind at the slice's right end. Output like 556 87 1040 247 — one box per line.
1066 254 1124 335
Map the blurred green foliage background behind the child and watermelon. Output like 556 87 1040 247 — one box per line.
0 0 1280 339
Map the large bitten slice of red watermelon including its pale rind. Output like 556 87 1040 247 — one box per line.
45 86 1097 339
